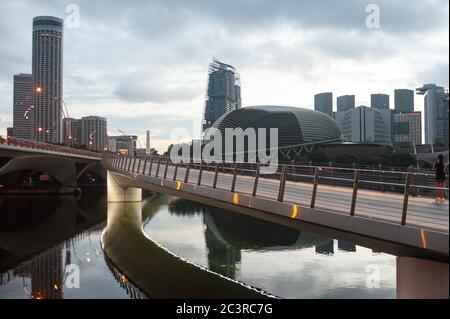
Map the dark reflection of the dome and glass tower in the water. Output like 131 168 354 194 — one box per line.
169 199 356 279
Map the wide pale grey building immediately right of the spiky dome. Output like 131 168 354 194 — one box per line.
338 106 392 144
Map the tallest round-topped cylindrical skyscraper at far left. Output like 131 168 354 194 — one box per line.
31 16 63 143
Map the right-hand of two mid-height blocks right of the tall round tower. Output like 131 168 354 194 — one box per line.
81 116 108 151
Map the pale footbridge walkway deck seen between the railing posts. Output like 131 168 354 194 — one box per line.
125 159 449 233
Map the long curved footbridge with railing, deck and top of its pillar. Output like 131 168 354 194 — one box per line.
103 154 449 262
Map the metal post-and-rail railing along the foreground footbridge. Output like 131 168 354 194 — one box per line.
103 155 449 231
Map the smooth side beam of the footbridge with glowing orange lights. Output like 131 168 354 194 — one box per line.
108 169 448 262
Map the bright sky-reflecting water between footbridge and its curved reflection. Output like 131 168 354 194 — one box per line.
144 198 396 298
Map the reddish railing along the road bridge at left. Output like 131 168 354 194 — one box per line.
0 136 102 159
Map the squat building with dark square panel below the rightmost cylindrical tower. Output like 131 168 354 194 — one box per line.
394 112 422 147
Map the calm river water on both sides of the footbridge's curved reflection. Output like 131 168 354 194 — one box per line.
0 190 396 298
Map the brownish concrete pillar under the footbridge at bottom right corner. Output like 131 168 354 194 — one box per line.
397 257 449 299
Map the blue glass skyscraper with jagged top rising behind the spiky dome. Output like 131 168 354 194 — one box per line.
203 59 241 132
